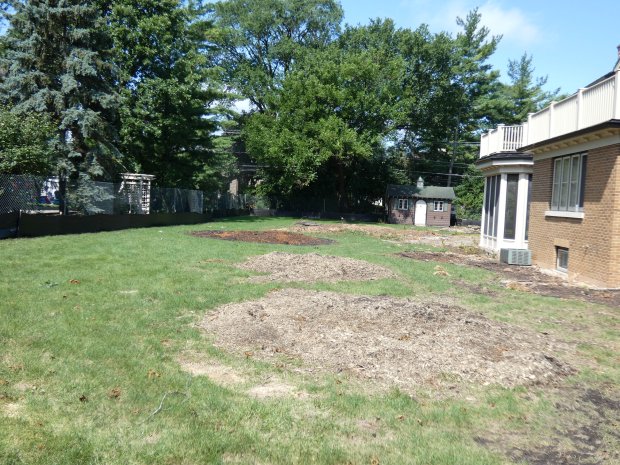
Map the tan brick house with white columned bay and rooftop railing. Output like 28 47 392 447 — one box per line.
477 46 620 288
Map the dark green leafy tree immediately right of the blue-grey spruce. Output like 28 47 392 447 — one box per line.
107 0 231 190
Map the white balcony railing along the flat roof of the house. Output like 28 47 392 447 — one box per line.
480 71 620 157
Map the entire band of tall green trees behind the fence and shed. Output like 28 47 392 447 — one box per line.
0 0 557 214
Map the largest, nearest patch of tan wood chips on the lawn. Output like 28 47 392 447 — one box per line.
202 289 572 390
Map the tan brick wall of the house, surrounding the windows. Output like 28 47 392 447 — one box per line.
529 144 620 287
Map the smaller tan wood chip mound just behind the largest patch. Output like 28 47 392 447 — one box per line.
239 252 394 282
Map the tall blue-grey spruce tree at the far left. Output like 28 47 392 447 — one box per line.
0 0 118 213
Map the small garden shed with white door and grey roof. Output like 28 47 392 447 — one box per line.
386 178 456 226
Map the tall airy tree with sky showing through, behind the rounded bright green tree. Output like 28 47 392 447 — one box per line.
211 0 343 112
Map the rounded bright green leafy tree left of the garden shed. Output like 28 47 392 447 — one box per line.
244 21 403 209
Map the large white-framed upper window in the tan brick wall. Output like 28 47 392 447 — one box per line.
551 153 588 212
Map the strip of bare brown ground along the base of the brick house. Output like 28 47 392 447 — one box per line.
399 251 620 308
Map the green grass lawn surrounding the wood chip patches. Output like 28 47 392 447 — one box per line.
0 218 620 465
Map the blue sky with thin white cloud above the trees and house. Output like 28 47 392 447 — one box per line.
340 0 620 93
